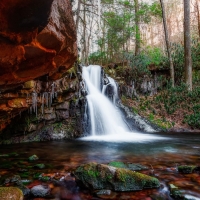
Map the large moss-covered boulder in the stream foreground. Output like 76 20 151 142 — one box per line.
74 163 160 191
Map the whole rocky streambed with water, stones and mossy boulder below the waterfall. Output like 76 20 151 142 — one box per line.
0 133 200 200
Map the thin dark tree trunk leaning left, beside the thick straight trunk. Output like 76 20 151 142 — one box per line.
160 0 175 87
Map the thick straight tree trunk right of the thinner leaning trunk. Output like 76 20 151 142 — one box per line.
184 0 192 91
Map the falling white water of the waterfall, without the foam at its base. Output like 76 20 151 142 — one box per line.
83 65 128 135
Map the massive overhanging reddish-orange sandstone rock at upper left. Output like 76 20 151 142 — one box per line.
0 0 77 90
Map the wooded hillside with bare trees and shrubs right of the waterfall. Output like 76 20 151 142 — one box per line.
72 0 200 131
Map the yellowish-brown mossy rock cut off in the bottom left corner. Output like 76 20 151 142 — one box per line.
0 187 23 200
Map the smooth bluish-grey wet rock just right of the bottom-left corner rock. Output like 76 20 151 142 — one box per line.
31 185 50 197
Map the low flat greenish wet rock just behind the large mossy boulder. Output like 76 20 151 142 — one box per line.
108 161 148 171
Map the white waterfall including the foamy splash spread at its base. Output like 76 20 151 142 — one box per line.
82 65 166 142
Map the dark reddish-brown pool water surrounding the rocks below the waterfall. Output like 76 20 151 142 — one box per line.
0 133 200 200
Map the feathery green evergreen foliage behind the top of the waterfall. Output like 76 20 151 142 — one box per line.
89 0 161 66
